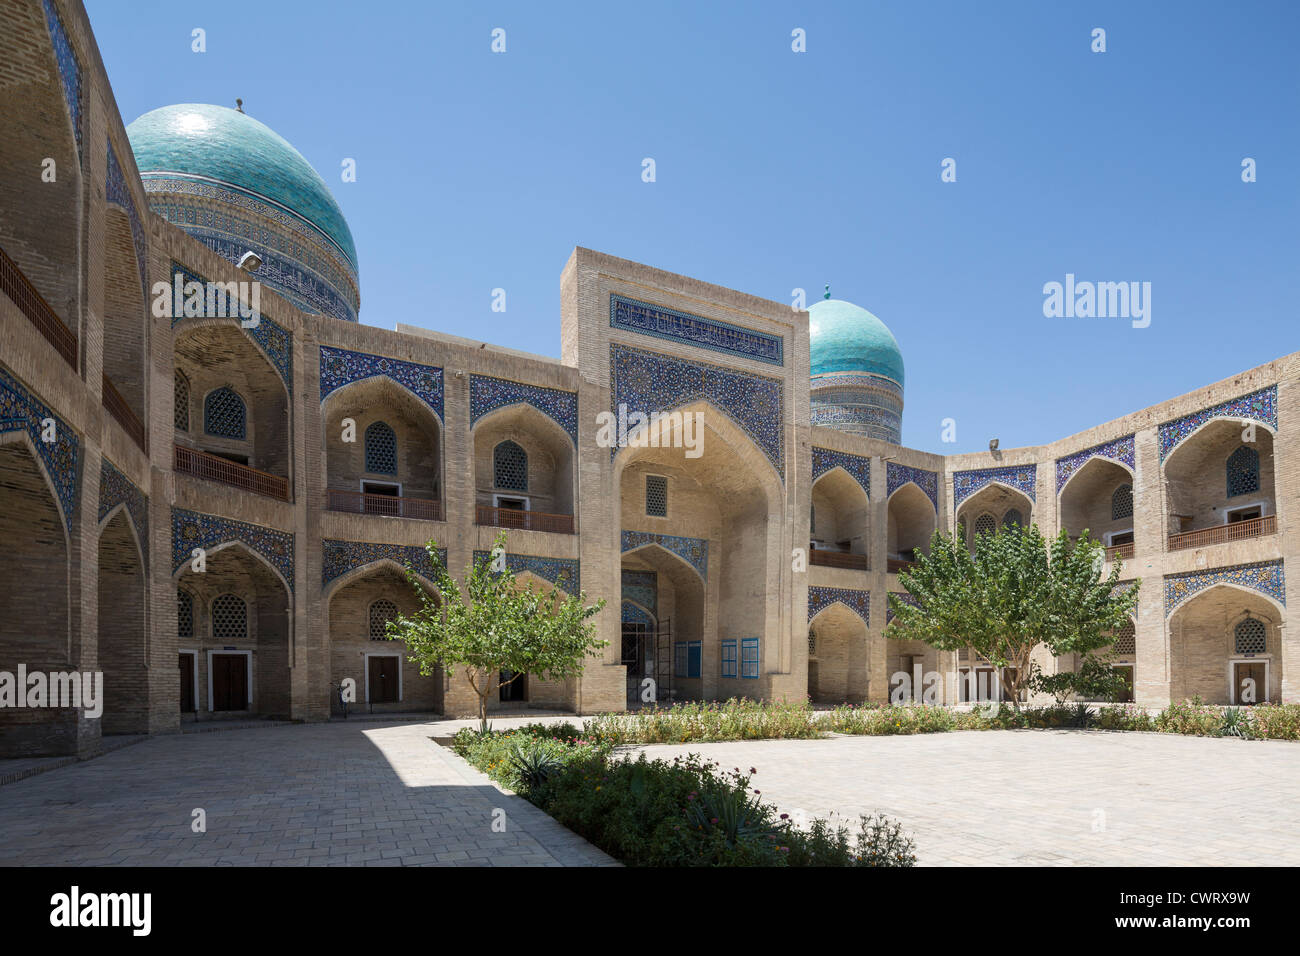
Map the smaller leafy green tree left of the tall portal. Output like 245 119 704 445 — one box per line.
386 532 608 731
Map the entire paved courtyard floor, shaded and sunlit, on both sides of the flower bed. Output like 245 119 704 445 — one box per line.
0 718 1300 866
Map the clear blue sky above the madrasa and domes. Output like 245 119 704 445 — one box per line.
86 0 1300 453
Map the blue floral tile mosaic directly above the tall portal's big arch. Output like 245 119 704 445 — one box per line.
610 345 785 483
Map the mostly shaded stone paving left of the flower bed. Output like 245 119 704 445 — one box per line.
0 721 614 866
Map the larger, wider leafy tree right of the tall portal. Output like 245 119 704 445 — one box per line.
887 525 1140 708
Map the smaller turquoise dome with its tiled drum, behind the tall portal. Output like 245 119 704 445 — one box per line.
809 299 904 445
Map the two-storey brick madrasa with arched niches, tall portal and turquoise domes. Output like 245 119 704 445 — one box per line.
0 0 1300 756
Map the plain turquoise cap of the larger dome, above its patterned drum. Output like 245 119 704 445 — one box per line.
126 103 356 269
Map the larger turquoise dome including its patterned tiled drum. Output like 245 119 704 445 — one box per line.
126 104 361 323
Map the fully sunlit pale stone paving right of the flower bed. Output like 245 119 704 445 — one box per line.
631 731 1300 866
